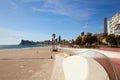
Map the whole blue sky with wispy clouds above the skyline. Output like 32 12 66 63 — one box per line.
0 0 120 45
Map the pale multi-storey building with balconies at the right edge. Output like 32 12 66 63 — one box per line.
108 11 120 35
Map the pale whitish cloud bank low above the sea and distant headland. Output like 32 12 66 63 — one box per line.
0 27 50 45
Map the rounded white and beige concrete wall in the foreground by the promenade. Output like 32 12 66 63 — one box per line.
63 55 110 80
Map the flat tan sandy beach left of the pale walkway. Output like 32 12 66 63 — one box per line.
0 47 57 80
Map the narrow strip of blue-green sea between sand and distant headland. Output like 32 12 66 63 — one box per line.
0 44 48 50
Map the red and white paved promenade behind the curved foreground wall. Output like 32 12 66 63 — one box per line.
63 48 120 79
